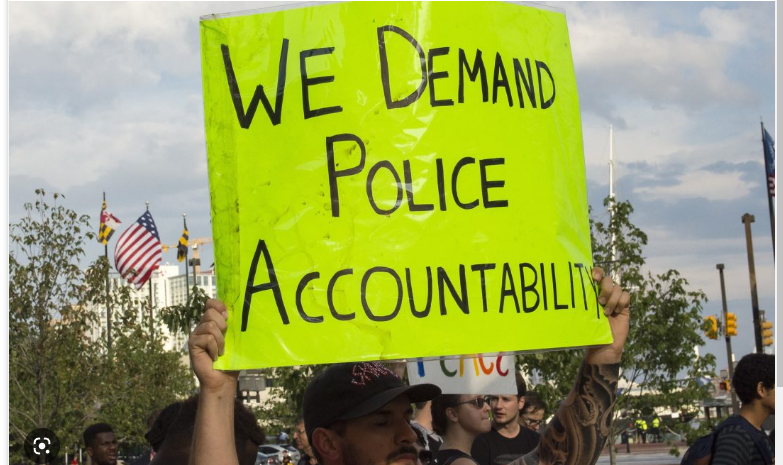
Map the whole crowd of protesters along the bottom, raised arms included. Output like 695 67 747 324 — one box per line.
76 268 774 465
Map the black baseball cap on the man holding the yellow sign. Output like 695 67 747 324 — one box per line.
302 362 440 438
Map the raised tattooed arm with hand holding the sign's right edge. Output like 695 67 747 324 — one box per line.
510 268 630 465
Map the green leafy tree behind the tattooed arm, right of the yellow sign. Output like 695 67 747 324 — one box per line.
518 198 715 463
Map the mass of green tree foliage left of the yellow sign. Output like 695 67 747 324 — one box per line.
9 190 196 462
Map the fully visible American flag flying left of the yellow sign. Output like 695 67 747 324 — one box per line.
114 210 161 289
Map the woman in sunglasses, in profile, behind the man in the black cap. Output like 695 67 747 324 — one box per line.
432 394 492 465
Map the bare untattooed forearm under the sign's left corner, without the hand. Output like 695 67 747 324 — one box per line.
190 381 239 465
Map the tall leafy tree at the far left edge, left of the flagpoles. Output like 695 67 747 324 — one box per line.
8 189 101 459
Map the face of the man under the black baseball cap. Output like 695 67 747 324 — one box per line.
341 395 418 465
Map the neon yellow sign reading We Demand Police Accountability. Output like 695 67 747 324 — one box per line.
201 2 611 369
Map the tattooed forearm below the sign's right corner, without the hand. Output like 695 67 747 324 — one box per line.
518 361 620 465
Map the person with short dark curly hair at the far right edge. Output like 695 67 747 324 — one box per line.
712 354 775 465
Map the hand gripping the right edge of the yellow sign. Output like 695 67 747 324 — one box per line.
586 267 631 364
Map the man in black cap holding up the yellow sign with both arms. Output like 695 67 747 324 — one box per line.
188 268 630 465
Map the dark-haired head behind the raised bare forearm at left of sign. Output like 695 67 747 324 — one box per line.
147 394 265 465
